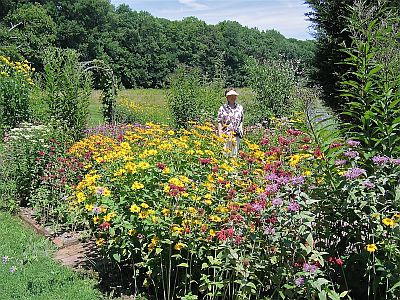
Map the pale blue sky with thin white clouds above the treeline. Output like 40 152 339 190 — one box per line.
111 0 312 40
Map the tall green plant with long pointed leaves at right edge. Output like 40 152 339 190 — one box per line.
342 1 400 156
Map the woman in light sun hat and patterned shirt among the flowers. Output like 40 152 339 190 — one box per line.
218 88 243 156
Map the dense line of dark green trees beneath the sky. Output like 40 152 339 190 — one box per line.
0 0 315 88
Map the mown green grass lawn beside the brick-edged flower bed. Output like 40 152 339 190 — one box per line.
0 212 102 300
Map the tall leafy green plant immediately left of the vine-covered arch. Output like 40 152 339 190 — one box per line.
43 49 91 136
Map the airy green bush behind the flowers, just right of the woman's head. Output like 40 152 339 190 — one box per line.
247 60 297 122
